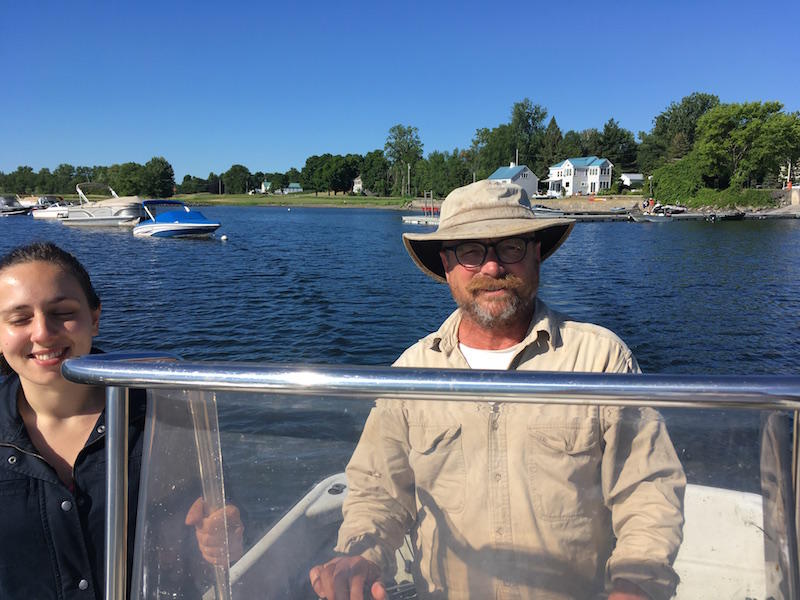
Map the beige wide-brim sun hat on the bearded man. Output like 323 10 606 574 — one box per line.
403 179 575 282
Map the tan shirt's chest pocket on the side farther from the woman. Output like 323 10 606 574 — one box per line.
526 418 603 521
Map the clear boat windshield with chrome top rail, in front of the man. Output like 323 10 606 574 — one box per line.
65 358 800 600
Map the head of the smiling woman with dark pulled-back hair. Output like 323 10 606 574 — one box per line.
0 261 100 386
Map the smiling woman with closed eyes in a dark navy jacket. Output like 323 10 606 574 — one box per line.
0 243 242 600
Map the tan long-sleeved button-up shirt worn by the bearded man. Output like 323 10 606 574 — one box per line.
337 301 686 600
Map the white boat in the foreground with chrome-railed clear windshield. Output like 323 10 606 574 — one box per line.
63 354 800 600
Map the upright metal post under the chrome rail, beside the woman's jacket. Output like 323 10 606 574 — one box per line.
104 387 128 600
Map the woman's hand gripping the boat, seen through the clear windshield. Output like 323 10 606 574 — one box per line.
186 498 244 566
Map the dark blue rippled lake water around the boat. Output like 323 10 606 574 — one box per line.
0 207 800 528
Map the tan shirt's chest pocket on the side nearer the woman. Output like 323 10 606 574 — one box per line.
408 425 467 512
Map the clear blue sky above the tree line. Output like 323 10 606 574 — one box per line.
0 0 800 181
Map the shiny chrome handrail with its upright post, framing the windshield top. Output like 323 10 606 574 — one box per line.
62 353 800 600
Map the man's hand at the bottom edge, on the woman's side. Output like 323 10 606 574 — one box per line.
308 556 388 600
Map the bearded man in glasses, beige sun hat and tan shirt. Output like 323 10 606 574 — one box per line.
310 181 686 600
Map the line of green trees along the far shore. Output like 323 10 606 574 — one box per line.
0 92 800 201
